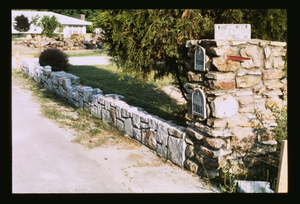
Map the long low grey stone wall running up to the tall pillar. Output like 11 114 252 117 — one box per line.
20 61 186 167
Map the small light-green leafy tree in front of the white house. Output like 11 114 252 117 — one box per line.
32 15 63 38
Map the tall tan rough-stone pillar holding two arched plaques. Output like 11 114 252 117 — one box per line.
185 39 287 177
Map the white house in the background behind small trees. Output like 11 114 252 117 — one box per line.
11 11 92 38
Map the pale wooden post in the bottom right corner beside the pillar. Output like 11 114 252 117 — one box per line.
275 140 288 193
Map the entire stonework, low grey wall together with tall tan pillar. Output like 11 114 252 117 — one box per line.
21 36 287 177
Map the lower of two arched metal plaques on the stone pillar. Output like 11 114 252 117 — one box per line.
192 89 206 119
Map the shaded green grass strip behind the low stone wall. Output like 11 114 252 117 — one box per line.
68 65 186 126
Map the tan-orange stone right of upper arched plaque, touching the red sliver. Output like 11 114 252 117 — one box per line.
212 57 240 72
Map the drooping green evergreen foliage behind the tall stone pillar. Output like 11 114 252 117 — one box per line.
95 9 287 100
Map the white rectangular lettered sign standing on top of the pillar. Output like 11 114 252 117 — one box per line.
215 24 251 40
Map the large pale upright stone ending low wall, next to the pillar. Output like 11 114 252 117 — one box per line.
168 136 186 167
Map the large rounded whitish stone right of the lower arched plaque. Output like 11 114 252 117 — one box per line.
211 94 239 118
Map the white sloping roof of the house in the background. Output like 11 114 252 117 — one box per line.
12 11 92 25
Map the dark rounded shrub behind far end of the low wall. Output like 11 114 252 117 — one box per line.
39 49 70 71
